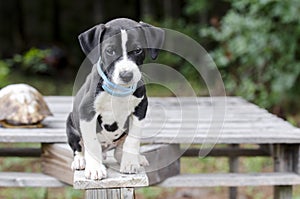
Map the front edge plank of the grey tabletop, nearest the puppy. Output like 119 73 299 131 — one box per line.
0 128 300 144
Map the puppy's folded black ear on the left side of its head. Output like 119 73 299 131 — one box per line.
78 24 105 63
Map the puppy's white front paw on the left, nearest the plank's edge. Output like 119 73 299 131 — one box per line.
84 164 107 180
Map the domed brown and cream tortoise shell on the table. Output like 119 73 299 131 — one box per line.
0 84 52 128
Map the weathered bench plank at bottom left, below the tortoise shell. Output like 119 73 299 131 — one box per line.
0 172 65 187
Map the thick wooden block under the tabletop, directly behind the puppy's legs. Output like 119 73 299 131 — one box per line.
41 143 180 186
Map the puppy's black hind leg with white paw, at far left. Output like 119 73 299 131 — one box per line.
67 113 85 171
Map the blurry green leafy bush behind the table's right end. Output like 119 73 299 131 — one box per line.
201 0 300 108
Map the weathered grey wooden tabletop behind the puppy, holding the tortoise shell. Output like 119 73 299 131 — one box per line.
0 97 300 144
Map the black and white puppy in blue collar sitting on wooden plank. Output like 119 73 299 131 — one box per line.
67 18 164 180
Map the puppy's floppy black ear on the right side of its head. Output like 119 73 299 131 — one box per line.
140 21 165 60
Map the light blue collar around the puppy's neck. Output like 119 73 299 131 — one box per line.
97 59 137 97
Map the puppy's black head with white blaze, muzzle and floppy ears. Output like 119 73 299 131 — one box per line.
79 18 164 86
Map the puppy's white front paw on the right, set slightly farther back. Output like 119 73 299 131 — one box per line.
120 152 141 174
